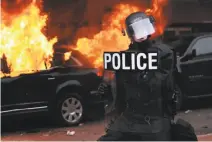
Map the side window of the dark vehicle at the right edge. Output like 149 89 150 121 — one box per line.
192 37 212 56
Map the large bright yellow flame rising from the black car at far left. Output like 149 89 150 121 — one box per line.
0 1 57 77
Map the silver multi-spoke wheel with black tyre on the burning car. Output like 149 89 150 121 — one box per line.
57 93 84 126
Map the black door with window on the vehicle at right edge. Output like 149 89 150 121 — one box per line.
180 35 212 97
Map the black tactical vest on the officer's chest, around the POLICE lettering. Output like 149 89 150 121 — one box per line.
121 43 166 116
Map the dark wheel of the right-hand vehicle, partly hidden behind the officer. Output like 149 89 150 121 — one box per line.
174 85 184 110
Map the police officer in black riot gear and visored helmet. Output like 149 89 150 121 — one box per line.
98 12 176 141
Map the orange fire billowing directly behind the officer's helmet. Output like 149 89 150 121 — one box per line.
76 0 167 68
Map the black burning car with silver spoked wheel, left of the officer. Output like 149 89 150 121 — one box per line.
1 51 102 125
